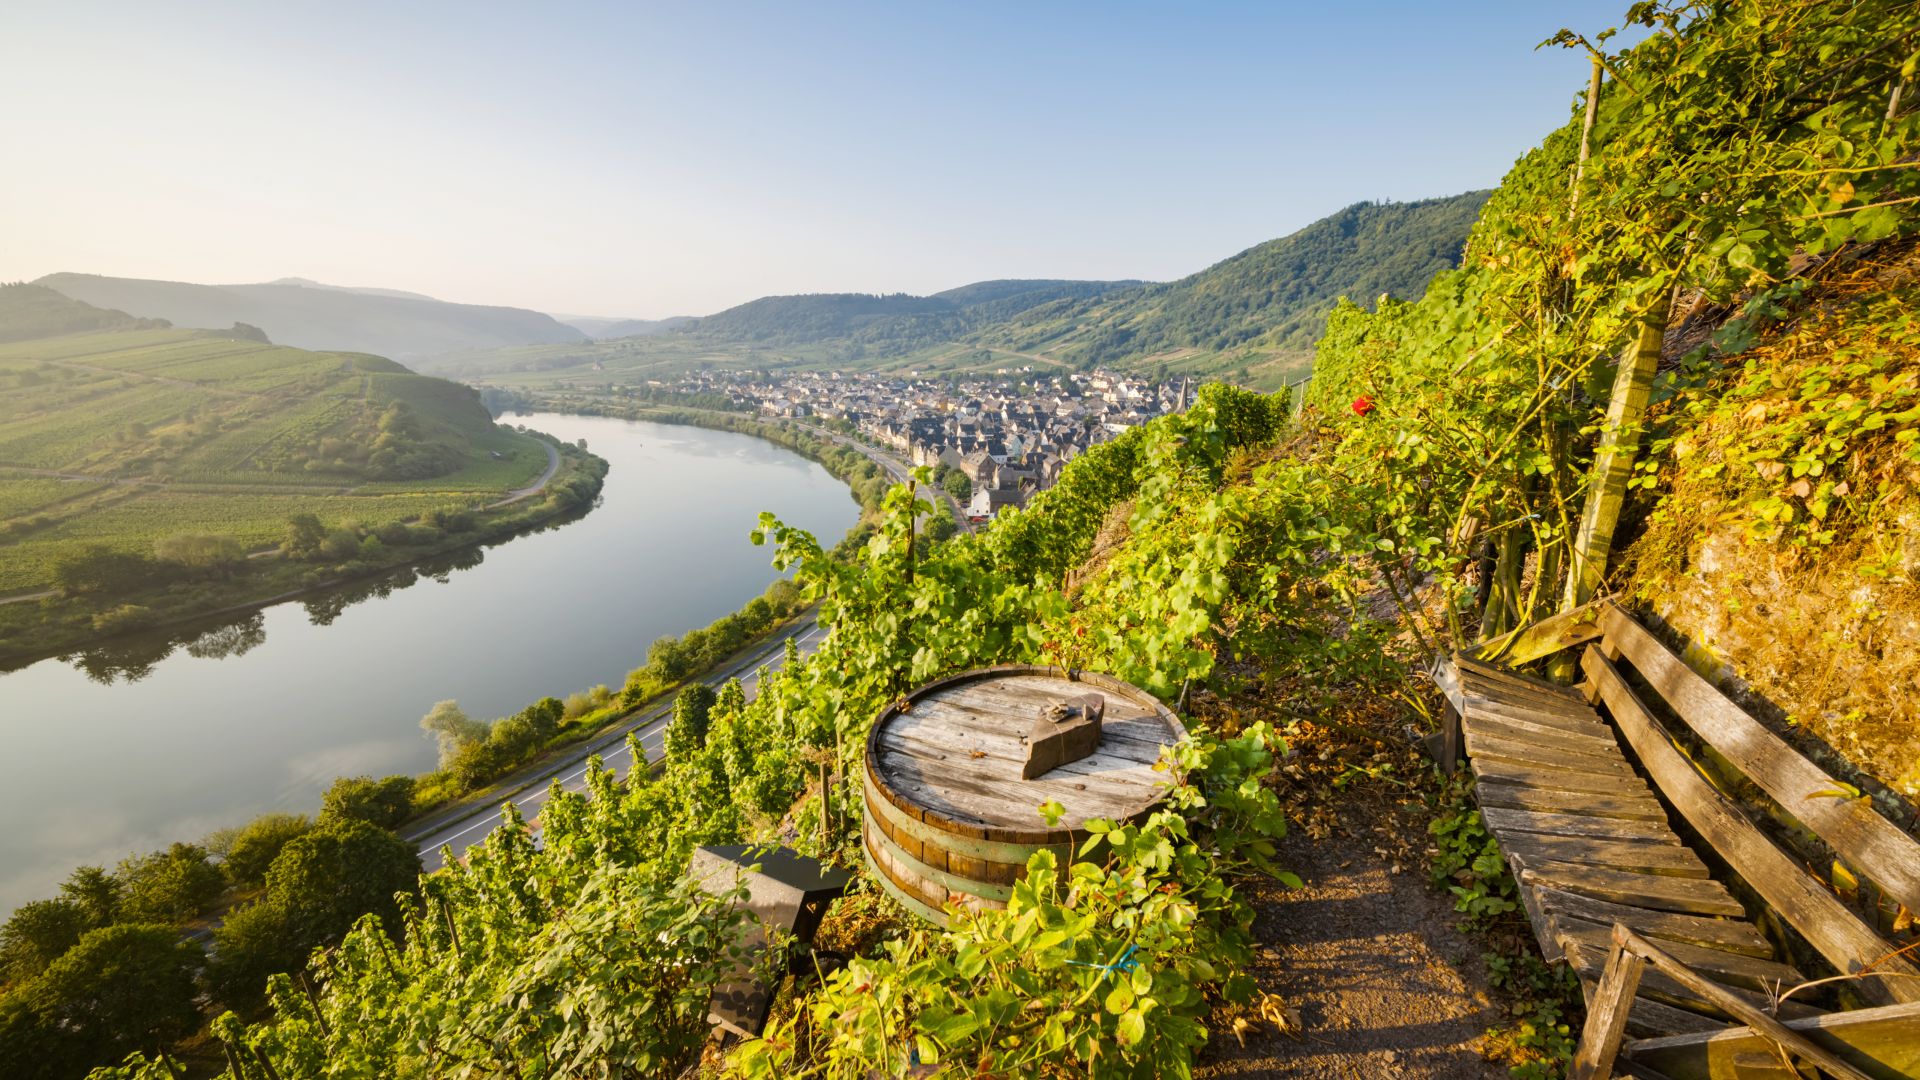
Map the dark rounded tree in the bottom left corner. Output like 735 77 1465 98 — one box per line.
0 922 200 1078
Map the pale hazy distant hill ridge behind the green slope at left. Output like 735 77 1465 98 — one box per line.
35 273 586 359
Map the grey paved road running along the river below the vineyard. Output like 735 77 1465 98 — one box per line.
401 613 826 871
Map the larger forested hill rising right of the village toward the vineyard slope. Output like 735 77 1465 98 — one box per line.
985 190 1490 369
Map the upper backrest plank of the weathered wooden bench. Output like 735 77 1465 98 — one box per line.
1601 603 1920 911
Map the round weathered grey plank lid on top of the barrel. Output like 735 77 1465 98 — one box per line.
866 665 1187 844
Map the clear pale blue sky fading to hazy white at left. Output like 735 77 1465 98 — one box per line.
0 0 1626 317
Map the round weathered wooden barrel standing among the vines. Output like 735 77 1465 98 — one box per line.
862 665 1187 926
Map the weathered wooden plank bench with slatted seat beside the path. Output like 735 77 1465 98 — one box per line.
1434 601 1920 1061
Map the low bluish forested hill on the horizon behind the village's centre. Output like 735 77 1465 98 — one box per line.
689 279 1140 352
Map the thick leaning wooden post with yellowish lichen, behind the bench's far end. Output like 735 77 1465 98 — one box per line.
1563 290 1672 609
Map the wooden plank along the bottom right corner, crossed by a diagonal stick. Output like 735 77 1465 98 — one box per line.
1626 1003 1920 1080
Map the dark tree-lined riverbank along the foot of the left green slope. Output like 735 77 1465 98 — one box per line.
0 438 607 671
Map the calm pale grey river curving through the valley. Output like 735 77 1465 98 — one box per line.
0 415 858 913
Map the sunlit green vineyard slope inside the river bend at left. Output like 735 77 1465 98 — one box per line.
0 319 547 596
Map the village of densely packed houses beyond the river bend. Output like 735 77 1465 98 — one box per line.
678 369 1192 525
